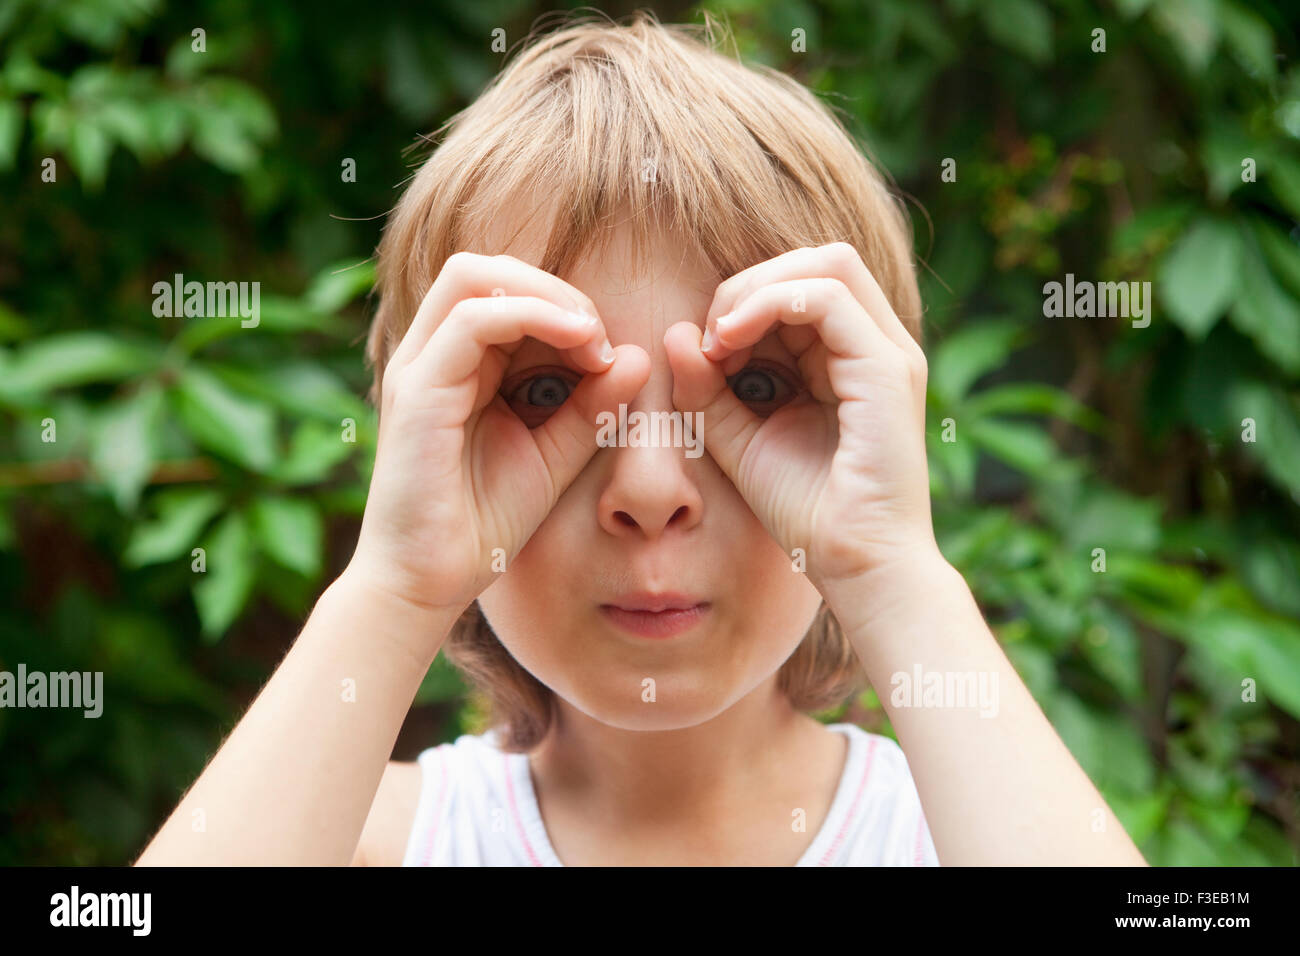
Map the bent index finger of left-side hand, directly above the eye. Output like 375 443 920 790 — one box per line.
408 295 608 389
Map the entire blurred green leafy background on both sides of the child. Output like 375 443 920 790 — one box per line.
0 0 1300 865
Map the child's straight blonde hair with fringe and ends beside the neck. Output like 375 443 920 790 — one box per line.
367 10 920 752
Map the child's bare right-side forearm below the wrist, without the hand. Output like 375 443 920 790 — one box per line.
823 551 1144 865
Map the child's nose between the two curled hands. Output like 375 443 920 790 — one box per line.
598 401 703 541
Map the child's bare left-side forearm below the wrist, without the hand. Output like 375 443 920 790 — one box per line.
138 574 454 865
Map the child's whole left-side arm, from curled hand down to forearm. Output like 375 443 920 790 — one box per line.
138 252 634 865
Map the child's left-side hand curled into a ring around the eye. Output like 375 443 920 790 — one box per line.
348 252 649 613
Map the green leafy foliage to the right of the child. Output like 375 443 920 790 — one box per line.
710 0 1300 865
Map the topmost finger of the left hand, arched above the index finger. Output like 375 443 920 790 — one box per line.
390 252 598 367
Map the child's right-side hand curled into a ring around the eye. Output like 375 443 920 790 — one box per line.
664 242 937 593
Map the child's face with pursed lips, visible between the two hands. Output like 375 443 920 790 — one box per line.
480 222 820 730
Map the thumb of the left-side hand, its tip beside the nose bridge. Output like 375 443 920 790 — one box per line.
533 345 650 494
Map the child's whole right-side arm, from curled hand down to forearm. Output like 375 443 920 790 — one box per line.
664 242 1143 865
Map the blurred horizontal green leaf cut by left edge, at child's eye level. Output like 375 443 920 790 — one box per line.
0 332 161 395
